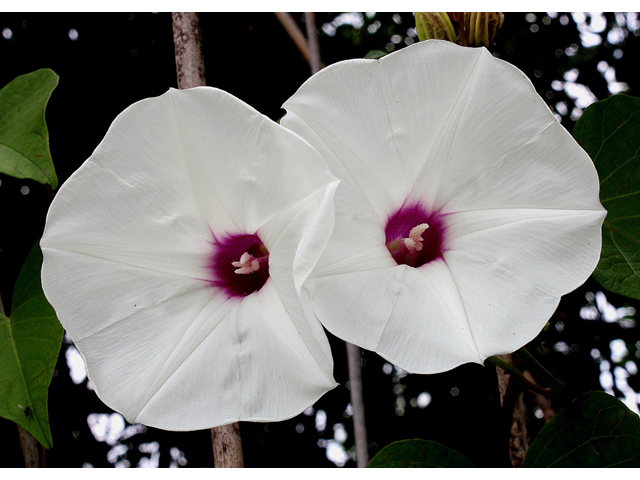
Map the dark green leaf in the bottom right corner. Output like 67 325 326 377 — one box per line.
524 392 640 468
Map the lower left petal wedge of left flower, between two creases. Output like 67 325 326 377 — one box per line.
42 247 232 428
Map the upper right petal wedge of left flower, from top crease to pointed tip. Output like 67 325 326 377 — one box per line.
170 87 335 232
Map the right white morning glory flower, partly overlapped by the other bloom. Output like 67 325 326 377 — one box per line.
281 40 606 373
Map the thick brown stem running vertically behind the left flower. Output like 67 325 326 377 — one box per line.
171 12 244 468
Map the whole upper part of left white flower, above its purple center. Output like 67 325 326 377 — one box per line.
45 87 334 278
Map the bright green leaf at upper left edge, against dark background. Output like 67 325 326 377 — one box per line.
0 68 58 189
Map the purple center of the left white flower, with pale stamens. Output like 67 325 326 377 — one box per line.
208 234 269 298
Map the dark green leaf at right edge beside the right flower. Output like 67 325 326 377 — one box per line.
573 95 640 299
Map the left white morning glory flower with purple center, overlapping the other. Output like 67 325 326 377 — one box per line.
41 87 338 430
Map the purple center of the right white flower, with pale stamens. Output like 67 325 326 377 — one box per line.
384 203 446 268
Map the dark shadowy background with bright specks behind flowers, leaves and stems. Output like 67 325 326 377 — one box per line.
0 13 640 467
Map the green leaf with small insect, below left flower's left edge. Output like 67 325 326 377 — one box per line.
0 244 63 448
